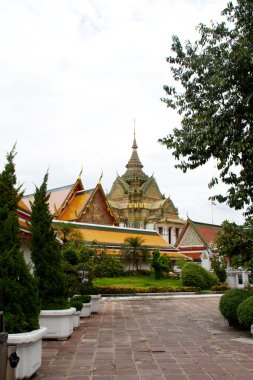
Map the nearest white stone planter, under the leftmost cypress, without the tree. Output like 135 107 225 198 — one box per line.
7 327 47 379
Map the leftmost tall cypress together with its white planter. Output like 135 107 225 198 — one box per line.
0 146 46 379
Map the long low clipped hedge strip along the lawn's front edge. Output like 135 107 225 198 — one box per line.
97 286 199 294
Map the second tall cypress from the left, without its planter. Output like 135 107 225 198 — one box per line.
31 173 68 310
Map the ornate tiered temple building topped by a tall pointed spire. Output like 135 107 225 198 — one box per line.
107 133 185 245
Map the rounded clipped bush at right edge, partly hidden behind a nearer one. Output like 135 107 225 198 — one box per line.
219 289 252 327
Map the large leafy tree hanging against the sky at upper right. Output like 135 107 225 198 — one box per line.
159 0 253 215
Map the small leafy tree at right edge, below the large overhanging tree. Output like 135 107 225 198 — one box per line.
216 218 253 270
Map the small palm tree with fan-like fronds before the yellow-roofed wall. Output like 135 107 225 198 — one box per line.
122 236 149 271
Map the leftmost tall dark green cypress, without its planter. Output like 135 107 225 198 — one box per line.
0 146 40 333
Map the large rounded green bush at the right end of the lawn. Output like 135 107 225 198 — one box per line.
181 263 218 289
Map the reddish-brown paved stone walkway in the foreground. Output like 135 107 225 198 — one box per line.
33 297 253 380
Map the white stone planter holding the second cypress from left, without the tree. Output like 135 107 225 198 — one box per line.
39 307 76 339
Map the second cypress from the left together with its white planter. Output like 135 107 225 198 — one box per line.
30 173 75 339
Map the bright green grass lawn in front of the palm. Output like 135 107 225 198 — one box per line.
93 275 182 288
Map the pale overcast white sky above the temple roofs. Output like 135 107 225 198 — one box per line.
0 0 244 224
